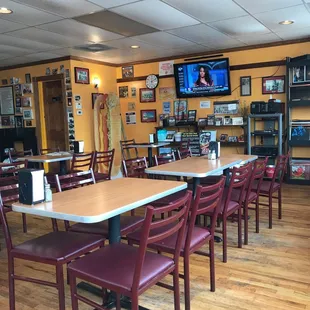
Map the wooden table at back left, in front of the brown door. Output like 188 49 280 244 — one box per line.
17 152 73 175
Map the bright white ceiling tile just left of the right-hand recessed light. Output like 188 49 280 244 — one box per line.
211 16 270 37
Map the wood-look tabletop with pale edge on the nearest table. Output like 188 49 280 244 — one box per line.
12 178 187 223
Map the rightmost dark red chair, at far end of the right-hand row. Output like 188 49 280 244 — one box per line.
253 155 289 229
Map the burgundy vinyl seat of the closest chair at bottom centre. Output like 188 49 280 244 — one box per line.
68 243 174 292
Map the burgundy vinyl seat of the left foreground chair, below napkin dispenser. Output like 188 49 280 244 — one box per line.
12 231 104 264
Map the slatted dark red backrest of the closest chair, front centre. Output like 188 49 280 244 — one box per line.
132 191 192 290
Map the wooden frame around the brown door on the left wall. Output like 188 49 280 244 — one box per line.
32 73 69 150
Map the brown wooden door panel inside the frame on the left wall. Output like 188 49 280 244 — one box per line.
43 80 66 151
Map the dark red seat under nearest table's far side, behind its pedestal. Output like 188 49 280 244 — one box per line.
69 216 144 237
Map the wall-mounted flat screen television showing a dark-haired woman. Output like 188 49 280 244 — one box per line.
174 58 231 98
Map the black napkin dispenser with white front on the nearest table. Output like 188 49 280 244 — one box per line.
18 169 45 205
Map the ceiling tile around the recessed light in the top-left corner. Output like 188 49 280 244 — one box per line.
1 0 62 26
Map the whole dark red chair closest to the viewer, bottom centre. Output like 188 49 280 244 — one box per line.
68 192 192 310
